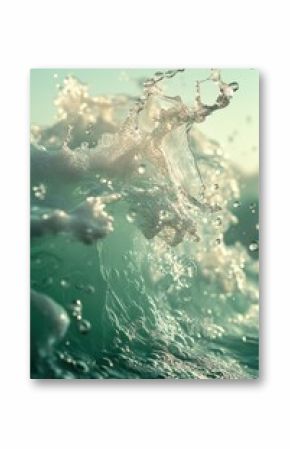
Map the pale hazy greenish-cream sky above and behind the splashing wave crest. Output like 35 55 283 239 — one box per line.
31 68 259 173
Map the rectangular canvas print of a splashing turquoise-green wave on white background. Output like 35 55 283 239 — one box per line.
31 69 259 379
